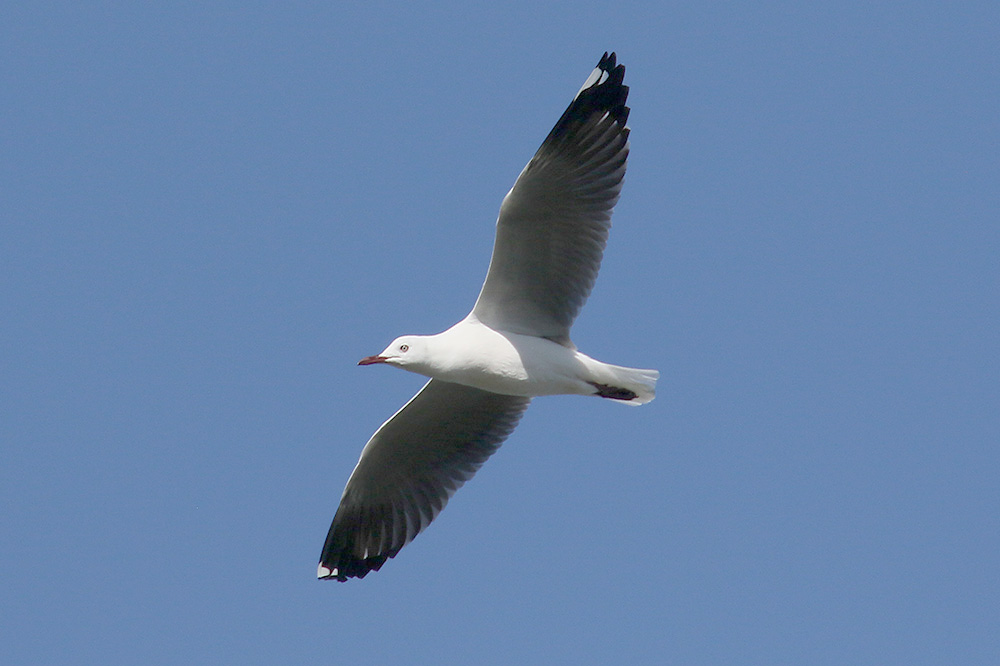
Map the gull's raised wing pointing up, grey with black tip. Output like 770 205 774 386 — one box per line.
472 53 629 345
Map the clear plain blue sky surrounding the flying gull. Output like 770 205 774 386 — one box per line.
0 1 1000 665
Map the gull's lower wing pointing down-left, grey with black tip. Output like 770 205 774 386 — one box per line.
318 379 531 581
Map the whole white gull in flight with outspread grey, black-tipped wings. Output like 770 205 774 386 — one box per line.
317 53 660 582
